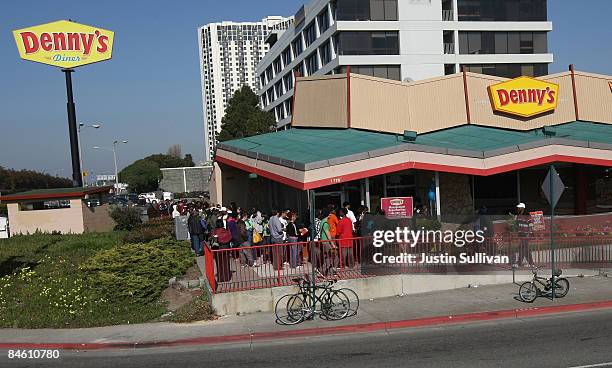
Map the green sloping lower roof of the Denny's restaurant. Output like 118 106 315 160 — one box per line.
218 121 612 170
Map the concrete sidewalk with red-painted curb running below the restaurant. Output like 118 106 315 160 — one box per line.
0 277 612 349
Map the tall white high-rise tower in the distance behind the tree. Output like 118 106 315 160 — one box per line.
198 17 292 161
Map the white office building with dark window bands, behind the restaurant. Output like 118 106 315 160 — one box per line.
257 0 553 127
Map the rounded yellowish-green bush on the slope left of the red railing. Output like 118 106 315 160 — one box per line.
81 238 194 304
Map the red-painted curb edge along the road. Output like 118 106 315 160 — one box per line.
0 300 612 350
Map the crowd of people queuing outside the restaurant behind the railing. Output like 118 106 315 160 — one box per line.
175 201 374 279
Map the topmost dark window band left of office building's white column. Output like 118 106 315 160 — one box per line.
332 0 397 21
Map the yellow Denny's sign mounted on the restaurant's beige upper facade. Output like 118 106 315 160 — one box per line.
489 77 559 118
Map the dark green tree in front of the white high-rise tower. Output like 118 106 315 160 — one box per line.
217 85 276 141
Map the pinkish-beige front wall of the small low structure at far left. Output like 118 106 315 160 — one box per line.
8 198 84 235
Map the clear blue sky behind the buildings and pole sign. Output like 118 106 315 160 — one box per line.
0 0 612 177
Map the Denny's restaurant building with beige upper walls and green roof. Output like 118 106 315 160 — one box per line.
210 67 612 222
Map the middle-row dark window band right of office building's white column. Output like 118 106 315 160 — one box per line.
459 32 547 54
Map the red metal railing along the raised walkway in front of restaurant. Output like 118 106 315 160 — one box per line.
205 234 612 293
